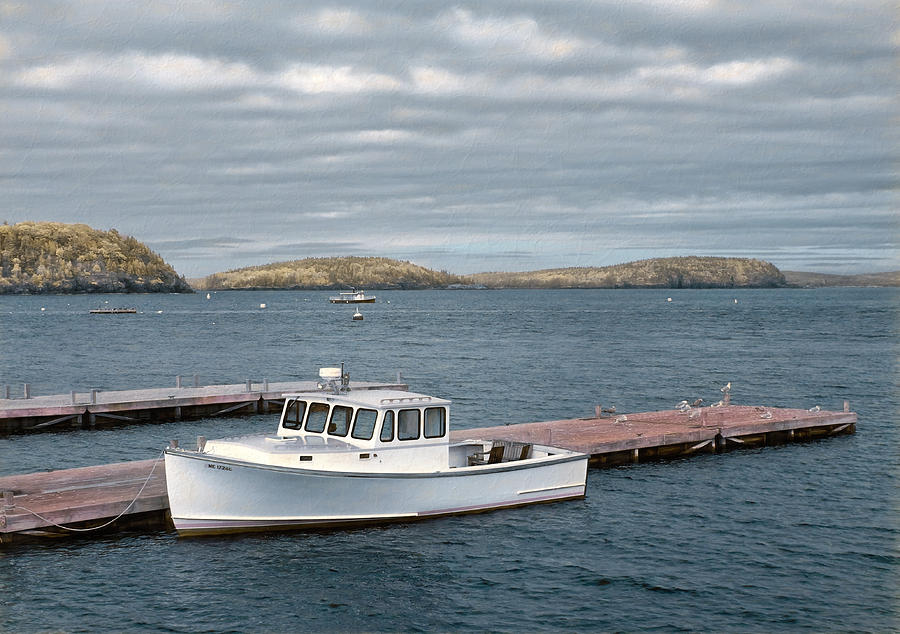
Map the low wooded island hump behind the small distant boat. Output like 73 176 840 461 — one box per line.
191 257 465 290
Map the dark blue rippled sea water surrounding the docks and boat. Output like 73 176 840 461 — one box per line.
0 288 900 632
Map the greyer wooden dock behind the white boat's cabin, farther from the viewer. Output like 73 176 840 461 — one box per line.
0 378 407 434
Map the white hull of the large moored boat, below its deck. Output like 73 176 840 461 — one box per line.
166 450 587 535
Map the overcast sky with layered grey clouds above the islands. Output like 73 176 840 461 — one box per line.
0 0 900 277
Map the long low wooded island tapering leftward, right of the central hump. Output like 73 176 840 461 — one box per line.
467 256 787 288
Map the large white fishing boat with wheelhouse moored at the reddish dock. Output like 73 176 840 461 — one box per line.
165 368 588 535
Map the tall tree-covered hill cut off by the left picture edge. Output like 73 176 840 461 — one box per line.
0 222 192 294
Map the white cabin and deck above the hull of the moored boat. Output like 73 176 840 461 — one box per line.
200 368 536 472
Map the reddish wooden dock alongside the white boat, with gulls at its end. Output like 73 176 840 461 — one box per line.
0 400 857 544
